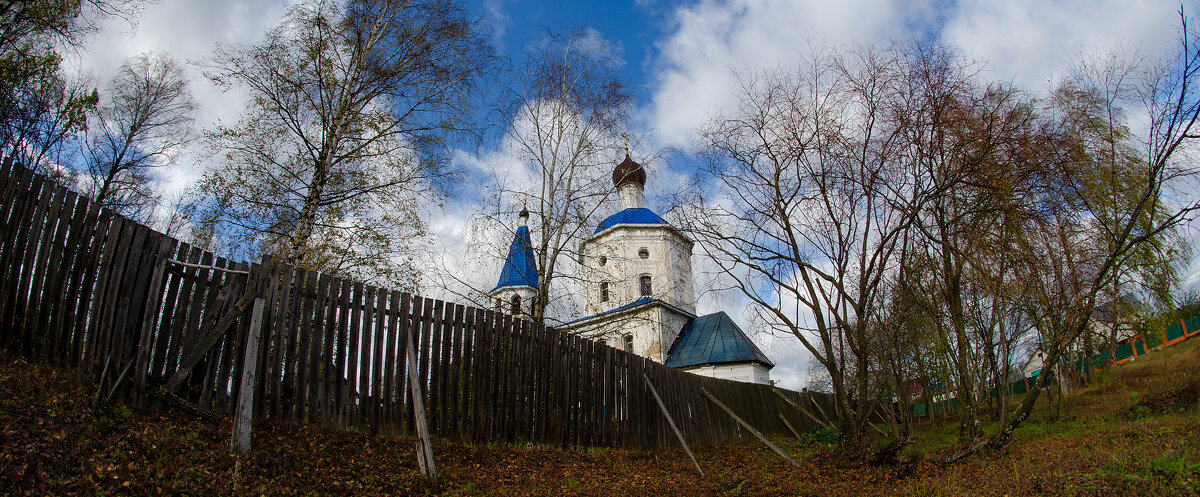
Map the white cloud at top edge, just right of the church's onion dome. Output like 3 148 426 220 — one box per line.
644 0 928 145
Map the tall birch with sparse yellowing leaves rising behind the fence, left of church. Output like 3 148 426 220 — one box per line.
200 0 493 288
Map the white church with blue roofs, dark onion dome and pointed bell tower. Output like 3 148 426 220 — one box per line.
490 150 774 384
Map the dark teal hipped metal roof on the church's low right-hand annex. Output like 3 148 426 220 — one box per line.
666 311 775 367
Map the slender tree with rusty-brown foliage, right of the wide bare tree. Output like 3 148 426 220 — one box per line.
902 43 1051 441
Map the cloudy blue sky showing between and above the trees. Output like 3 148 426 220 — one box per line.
67 0 1200 389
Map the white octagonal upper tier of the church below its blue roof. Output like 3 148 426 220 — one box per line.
581 224 696 316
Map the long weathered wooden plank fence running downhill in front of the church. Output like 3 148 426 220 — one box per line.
0 159 833 447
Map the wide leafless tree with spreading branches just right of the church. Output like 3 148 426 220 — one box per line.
685 44 923 453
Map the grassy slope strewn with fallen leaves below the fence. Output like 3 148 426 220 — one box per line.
0 340 1200 496
